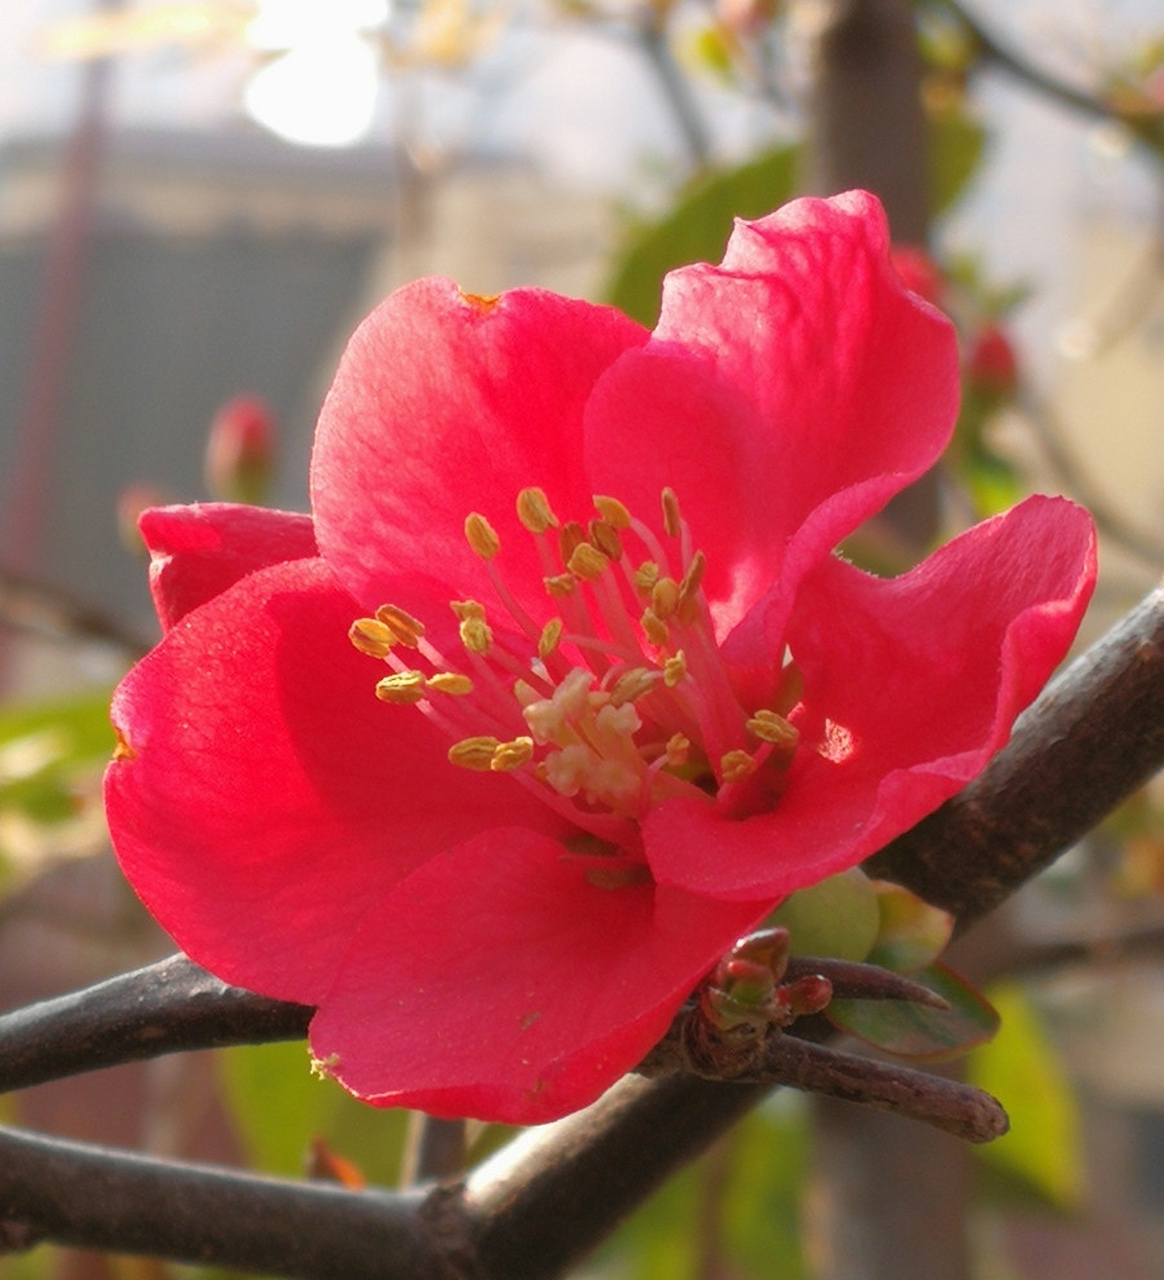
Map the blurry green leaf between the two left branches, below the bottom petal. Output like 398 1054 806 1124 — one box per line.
219 1043 408 1187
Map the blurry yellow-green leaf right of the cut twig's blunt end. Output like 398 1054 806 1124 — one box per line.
967 983 1085 1210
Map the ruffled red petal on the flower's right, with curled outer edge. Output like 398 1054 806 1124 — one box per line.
644 498 1095 897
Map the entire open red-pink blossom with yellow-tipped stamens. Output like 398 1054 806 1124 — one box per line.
108 193 1095 1121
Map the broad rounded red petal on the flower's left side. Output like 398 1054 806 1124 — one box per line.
106 561 562 1004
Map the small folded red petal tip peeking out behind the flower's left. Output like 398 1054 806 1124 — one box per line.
140 502 318 631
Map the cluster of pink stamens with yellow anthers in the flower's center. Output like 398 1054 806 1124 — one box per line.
348 488 799 847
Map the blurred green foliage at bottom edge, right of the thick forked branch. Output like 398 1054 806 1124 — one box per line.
602 1098 808 1280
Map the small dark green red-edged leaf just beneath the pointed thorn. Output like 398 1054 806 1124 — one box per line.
825 964 999 1062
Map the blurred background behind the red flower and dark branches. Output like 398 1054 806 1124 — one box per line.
0 0 1164 1280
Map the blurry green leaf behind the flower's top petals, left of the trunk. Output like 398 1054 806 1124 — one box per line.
606 147 798 326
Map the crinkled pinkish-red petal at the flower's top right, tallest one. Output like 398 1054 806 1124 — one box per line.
586 192 958 662
